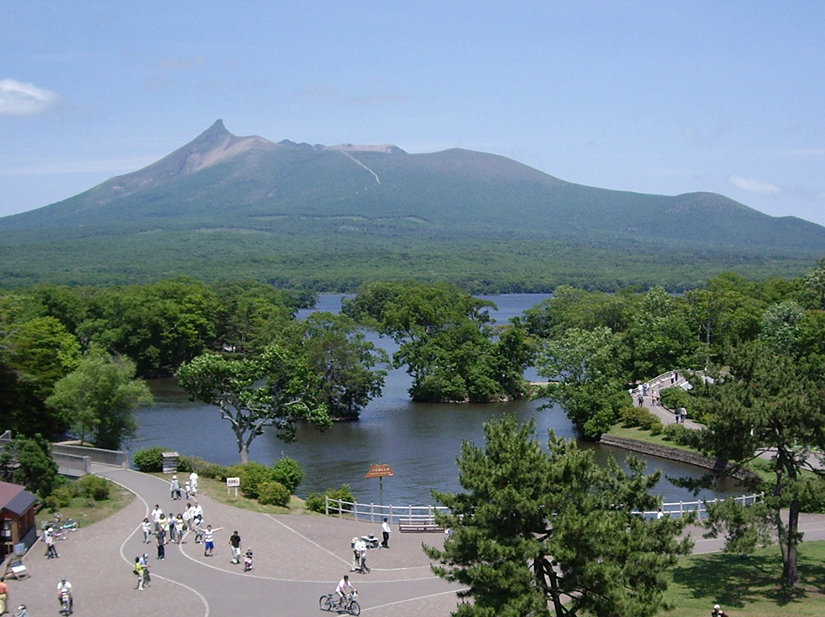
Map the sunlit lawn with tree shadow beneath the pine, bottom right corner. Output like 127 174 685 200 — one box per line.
659 541 825 617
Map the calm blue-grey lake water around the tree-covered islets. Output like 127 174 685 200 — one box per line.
130 294 737 505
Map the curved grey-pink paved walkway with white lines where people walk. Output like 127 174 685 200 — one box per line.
8 466 458 617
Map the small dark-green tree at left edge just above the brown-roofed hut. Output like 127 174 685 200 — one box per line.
0 435 58 499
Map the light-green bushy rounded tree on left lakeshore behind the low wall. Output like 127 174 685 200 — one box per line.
46 347 152 450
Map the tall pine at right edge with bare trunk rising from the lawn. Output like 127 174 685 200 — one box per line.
693 341 825 585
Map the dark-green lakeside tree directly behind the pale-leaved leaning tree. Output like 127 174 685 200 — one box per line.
302 313 389 420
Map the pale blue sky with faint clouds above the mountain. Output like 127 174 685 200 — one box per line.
0 0 825 227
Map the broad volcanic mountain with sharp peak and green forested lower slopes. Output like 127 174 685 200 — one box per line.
0 120 825 287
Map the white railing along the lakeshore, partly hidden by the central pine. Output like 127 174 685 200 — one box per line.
325 493 765 525
